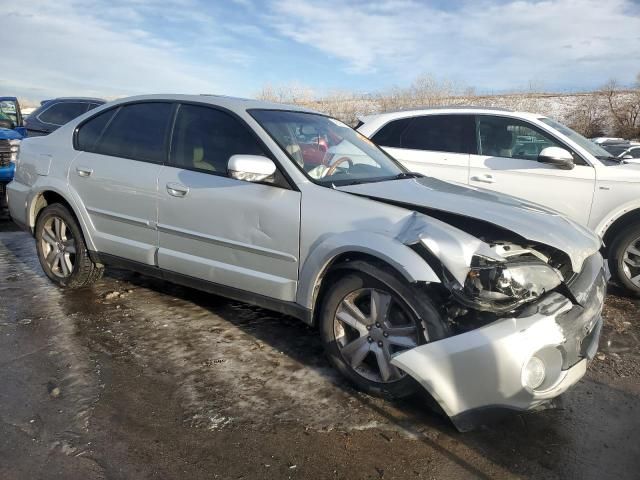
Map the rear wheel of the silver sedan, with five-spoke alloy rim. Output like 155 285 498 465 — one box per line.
35 204 103 288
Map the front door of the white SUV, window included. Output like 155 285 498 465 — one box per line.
469 115 596 225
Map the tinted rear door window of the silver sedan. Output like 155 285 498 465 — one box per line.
93 102 173 163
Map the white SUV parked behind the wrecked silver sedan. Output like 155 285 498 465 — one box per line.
358 107 640 294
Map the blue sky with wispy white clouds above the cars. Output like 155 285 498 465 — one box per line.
0 0 640 100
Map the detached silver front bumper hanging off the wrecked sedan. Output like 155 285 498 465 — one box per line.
392 253 607 431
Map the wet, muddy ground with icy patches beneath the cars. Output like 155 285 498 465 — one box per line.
0 221 640 480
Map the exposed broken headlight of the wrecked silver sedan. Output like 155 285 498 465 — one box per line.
454 256 563 312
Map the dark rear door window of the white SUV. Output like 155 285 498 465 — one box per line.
400 115 475 153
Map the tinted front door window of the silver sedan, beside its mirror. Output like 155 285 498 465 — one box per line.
170 105 265 175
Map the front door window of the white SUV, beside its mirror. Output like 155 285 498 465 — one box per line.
476 116 566 161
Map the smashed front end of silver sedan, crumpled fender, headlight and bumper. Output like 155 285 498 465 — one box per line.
392 210 607 431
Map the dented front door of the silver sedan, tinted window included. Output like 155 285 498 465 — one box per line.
158 104 300 301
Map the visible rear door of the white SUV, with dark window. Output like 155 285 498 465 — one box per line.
372 114 475 183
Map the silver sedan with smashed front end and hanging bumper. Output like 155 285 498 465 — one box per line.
9 95 606 430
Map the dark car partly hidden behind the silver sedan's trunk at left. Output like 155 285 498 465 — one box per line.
25 97 105 137
